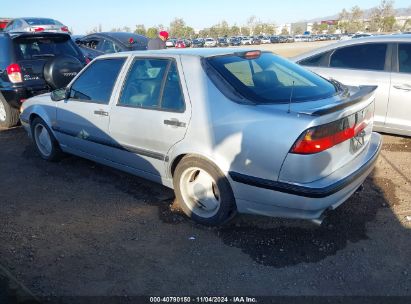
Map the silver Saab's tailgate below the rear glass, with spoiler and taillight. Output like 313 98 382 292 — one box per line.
279 87 376 184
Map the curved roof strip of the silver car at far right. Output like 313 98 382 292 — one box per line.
291 34 411 61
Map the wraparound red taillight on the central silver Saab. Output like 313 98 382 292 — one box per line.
291 106 373 154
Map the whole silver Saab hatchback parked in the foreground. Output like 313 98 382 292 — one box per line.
21 49 381 225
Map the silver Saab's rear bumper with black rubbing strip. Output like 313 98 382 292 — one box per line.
229 133 382 219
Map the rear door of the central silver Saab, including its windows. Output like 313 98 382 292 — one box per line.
110 57 191 181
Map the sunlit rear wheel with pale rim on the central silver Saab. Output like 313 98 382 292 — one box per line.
173 156 236 226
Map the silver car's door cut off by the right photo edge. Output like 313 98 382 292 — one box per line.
386 43 411 135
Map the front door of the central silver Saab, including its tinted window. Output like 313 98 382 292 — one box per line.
53 58 126 157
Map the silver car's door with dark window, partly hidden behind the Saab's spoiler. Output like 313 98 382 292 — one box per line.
299 43 391 127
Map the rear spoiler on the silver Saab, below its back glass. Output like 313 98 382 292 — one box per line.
301 86 378 116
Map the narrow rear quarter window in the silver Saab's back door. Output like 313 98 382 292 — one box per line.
161 62 185 112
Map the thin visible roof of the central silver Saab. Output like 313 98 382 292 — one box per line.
98 48 266 58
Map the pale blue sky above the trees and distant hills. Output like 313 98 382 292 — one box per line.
0 0 411 34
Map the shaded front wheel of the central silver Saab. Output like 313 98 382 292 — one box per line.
30 117 63 161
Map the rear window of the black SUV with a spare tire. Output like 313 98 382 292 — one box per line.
14 36 84 62
